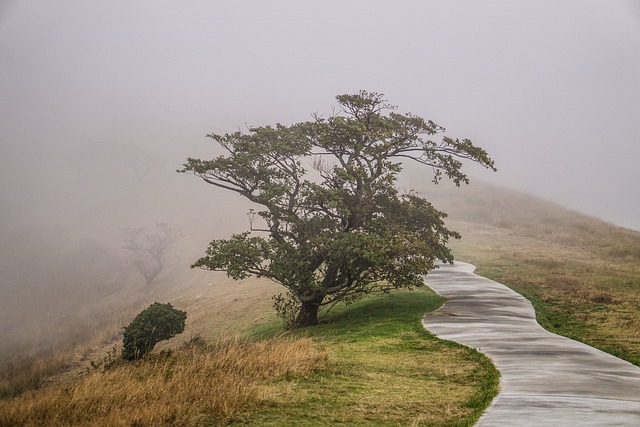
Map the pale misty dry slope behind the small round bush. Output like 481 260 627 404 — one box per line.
0 265 277 398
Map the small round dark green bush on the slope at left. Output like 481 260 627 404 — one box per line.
122 302 187 360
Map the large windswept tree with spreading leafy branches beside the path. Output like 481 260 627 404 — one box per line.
179 91 495 327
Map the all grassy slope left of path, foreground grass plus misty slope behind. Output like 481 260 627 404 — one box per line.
0 190 498 425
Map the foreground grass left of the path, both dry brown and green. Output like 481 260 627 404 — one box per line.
0 289 498 426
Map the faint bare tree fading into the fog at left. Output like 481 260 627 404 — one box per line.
124 222 180 285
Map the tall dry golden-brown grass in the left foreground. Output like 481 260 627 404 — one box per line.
0 338 327 426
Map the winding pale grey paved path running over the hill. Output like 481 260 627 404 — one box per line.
423 262 640 427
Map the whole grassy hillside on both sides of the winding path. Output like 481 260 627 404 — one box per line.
0 177 640 425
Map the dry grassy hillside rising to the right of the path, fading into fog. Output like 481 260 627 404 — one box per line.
425 183 640 365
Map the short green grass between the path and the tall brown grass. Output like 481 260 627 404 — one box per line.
238 289 499 426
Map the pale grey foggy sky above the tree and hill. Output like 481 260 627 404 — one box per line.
0 0 640 230
